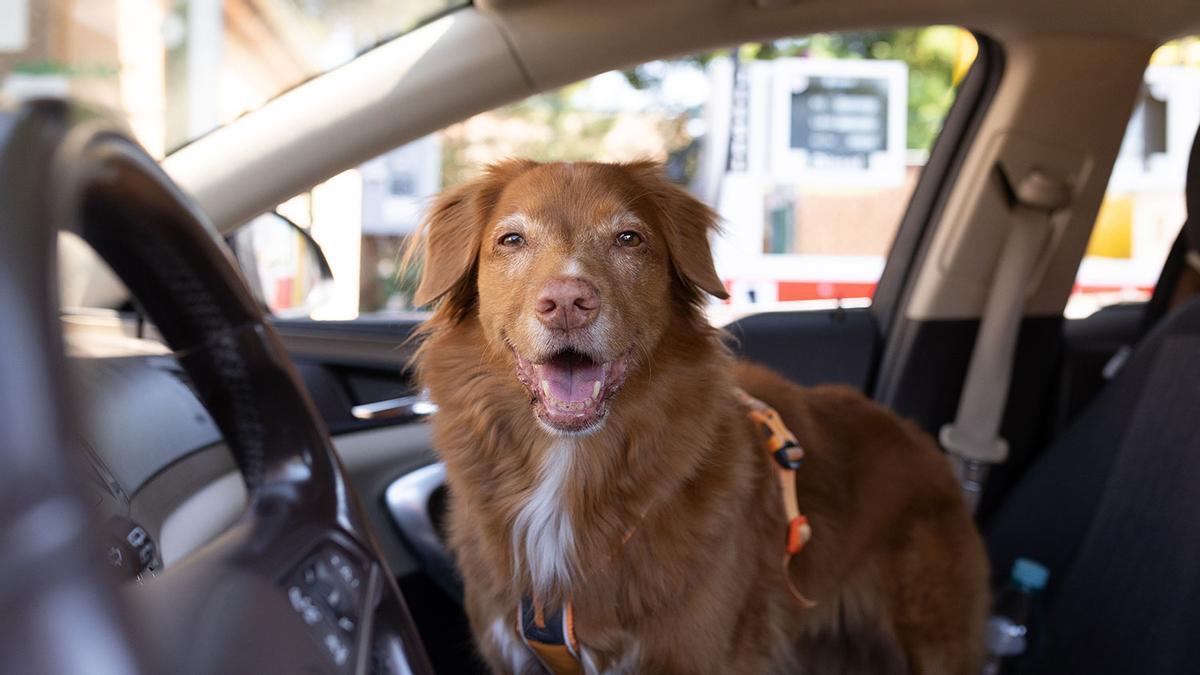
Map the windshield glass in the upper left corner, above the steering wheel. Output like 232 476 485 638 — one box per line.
0 0 469 157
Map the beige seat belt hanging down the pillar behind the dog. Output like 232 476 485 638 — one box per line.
938 168 1070 513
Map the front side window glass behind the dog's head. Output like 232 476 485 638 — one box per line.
260 26 976 318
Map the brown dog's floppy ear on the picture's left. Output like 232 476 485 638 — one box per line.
404 160 536 306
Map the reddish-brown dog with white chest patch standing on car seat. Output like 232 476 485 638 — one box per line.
416 161 988 674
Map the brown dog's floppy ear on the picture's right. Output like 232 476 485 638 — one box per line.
624 161 730 301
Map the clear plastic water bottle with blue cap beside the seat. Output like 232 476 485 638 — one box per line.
983 557 1050 675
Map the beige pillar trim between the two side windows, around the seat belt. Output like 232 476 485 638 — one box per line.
907 37 1156 319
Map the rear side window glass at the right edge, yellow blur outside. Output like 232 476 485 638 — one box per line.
1066 37 1200 318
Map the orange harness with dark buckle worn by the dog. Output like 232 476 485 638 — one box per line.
517 388 816 675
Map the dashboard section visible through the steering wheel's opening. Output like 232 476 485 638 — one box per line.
66 322 246 579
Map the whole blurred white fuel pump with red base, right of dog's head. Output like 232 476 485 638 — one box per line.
700 58 907 303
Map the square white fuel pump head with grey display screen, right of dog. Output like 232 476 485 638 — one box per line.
770 59 908 187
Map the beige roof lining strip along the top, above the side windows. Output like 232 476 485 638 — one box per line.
476 0 1200 96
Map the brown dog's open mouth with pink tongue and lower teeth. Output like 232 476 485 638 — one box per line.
514 350 626 434
